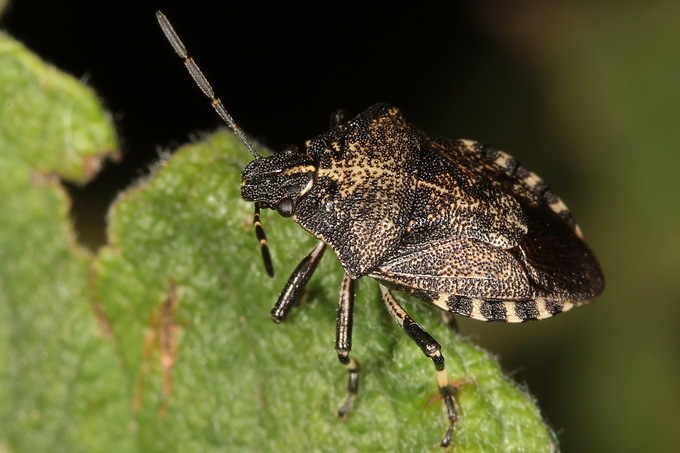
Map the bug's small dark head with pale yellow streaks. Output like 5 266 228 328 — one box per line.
241 147 316 217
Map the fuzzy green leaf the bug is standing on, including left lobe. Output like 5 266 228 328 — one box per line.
0 30 555 452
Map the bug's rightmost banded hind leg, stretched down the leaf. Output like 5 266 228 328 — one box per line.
380 285 458 447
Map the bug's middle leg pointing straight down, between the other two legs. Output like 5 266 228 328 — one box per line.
335 274 359 418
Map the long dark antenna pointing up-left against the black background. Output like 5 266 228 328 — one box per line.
156 11 262 159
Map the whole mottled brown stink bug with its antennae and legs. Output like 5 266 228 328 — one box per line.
157 12 604 447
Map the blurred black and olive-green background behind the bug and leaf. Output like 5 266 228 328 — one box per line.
0 0 680 452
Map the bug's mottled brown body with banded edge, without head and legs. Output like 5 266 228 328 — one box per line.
282 104 604 322
